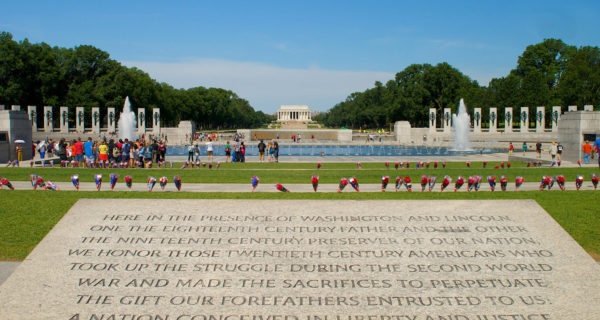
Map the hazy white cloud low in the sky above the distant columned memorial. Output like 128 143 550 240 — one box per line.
124 59 394 113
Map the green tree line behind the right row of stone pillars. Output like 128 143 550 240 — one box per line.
316 39 600 128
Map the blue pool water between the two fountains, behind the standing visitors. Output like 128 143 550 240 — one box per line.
167 144 501 157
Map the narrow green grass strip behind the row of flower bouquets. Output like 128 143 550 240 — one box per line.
0 162 600 183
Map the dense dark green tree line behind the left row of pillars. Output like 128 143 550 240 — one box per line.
0 32 274 129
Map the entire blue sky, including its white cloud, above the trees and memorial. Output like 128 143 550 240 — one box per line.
0 0 600 113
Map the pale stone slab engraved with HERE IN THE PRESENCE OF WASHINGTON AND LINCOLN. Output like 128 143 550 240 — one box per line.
0 199 600 320
